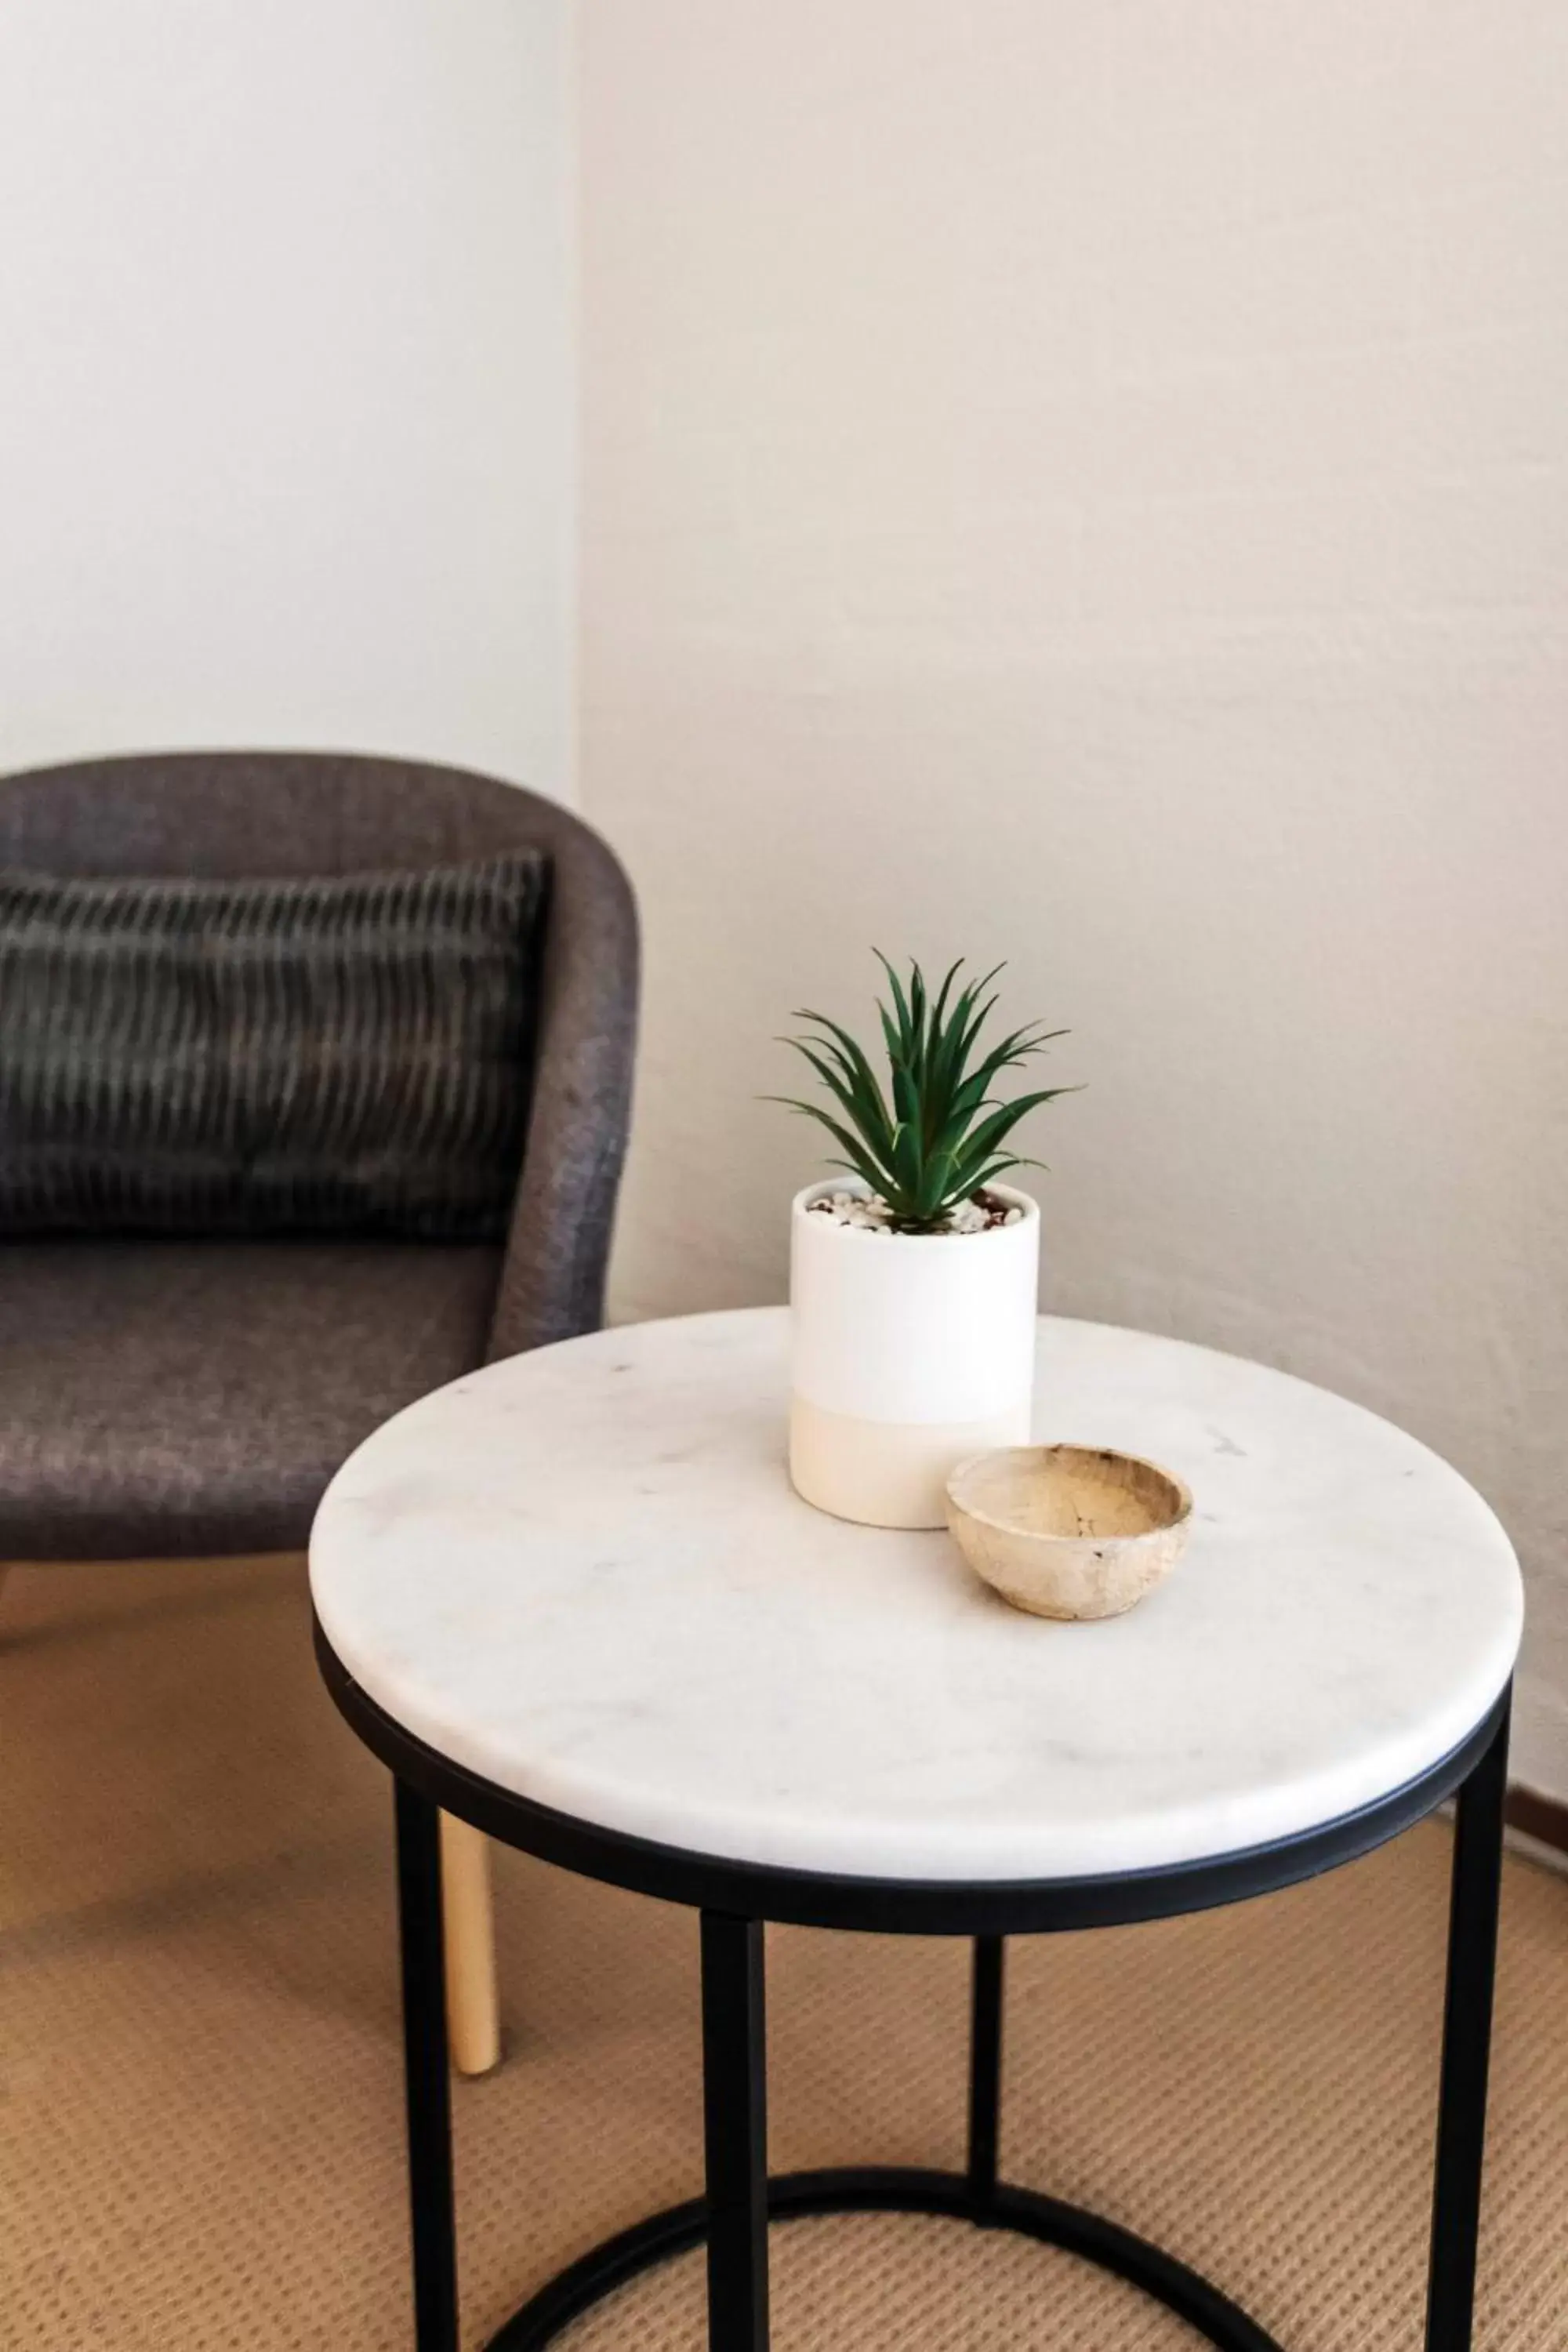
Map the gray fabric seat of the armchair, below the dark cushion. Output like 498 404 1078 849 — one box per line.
0 1242 501 1559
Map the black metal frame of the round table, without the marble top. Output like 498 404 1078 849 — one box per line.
315 1625 1509 2352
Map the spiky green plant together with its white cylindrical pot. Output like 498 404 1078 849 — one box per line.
776 955 1067 1526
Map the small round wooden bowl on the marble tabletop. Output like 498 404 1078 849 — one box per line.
947 1446 1192 1618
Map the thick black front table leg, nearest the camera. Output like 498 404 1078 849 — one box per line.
703 1912 769 2352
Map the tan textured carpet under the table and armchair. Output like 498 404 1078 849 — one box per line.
0 1562 1568 2352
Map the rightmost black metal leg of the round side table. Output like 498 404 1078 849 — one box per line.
1427 1710 1509 2352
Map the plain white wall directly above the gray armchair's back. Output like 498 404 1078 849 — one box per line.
0 0 574 793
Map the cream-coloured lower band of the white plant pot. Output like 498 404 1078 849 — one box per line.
789 1383 1029 1526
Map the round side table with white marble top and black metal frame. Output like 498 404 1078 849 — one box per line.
310 1310 1521 2352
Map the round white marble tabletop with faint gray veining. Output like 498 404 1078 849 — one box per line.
310 1308 1521 1879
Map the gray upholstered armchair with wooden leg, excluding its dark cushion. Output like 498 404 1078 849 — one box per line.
0 753 637 2063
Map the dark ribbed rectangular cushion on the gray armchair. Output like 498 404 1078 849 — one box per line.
0 851 546 1240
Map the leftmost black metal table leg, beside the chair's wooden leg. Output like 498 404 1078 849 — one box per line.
395 1780 459 2352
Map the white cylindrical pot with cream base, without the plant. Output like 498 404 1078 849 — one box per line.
789 1178 1039 1526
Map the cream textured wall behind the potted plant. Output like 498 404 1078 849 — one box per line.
581 0 1568 1795
